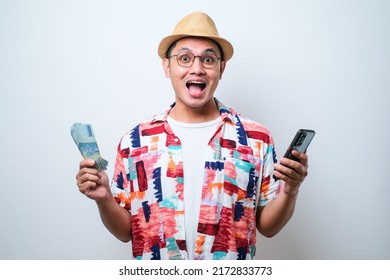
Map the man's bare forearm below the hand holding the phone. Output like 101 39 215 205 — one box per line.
257 187 298 237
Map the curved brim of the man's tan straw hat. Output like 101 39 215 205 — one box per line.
158 34 234 61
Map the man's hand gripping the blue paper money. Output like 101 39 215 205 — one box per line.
76 159 111 201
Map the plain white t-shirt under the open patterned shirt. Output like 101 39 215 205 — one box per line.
168 116 221 260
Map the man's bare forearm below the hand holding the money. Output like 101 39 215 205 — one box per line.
96 196 132 242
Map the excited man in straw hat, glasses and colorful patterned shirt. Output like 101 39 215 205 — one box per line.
76 12 308 259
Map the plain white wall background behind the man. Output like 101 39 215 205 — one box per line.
0 0 390 259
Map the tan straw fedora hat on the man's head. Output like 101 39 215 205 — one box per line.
158 12 233 61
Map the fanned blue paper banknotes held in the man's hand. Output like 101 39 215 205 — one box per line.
70 122 108 170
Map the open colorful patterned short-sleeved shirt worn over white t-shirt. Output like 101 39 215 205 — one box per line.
112 99 279 260
